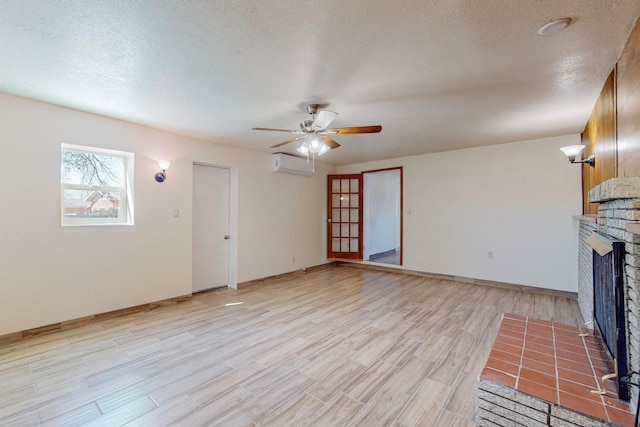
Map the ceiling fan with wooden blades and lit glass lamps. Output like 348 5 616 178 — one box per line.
253 104 382 156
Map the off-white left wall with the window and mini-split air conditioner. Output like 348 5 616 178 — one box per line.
0 94 335 335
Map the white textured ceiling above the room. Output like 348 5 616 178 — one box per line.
0 0 640 165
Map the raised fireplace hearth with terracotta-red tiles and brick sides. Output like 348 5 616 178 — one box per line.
477 314 634 426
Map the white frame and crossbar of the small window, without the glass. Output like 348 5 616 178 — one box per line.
60 144 134 227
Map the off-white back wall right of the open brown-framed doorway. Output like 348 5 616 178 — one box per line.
338 135 582 292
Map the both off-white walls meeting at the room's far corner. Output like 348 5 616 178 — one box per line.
0 94 581 335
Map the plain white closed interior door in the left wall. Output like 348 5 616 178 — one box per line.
192 165 232 292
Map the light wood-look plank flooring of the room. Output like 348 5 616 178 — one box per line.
0 265 580 427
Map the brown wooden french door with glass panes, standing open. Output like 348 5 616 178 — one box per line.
327 174 362 260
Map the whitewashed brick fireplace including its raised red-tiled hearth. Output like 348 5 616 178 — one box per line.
477 177 640 426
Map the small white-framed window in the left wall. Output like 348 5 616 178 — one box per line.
60 144 133 226
